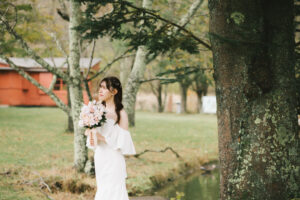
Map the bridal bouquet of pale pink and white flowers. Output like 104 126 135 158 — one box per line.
79 100 106 146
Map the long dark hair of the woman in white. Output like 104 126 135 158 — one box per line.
98 76 124 124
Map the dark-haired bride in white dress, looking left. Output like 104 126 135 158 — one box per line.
86 76 136 200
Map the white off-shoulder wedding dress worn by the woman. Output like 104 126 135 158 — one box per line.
86 118 136 200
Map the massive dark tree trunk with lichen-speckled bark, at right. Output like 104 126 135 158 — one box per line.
209 0 300 200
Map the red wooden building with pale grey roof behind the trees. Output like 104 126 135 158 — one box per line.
0 58 101 106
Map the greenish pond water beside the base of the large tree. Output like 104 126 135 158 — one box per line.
155 168 220 200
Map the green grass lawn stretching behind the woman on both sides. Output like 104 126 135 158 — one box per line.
0 107 218 199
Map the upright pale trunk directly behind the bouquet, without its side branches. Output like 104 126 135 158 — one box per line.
69 0 87 172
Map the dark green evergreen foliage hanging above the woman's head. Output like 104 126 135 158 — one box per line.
77 0 199 58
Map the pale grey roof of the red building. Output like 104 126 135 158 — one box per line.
0 57 101 71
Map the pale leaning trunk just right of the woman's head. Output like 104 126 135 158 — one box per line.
124 0 153 126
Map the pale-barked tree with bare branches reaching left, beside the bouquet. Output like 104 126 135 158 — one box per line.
0 1 91 171
